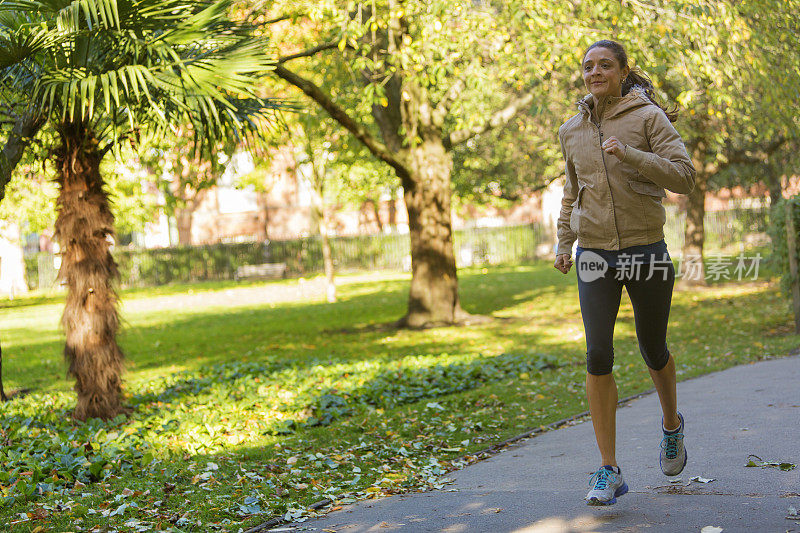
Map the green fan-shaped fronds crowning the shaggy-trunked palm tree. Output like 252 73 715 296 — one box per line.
0 0 291 155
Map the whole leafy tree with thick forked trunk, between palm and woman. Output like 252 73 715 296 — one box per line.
265 0 565 327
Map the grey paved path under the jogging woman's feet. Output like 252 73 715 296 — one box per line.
273 356 800 533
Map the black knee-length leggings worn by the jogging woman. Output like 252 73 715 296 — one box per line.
578 262 675 376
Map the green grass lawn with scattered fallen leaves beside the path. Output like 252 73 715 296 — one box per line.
0 256 798 531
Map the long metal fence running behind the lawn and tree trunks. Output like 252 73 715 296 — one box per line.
25 206 768 289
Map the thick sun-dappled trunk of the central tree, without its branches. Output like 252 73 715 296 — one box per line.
399 138 470 328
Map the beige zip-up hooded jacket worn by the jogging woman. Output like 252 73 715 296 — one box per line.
556 87 695 254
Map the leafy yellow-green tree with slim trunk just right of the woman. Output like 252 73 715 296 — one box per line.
598 0 800 285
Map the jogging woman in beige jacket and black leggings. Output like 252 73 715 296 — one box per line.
554 40 695 505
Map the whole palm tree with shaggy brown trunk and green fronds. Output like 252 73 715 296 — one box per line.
0 0 284 420
